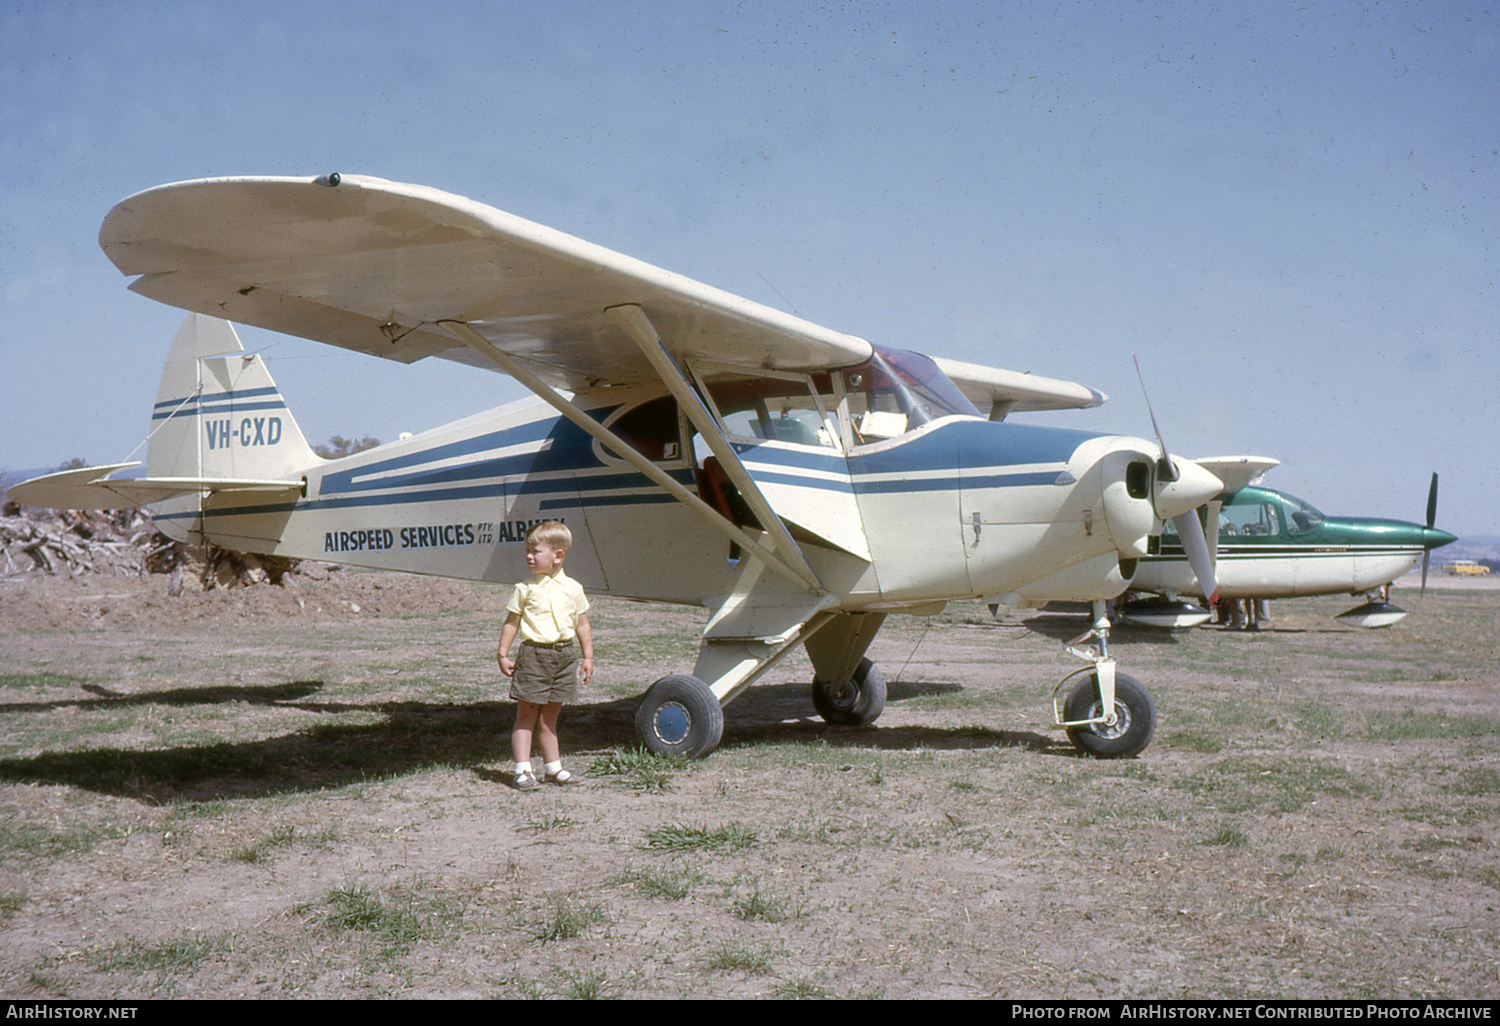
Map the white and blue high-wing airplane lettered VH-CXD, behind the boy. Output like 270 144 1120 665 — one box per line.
11 174 1224 758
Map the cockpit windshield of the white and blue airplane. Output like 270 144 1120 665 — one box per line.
843 350 980 441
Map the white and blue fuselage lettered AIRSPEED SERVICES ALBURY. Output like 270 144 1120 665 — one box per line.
158 396 1151 609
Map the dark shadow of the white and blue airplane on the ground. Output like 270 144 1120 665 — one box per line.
0 681 1074 804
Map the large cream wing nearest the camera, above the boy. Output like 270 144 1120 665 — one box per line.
99 176 872 392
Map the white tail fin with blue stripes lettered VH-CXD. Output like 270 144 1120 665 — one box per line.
146 314 320 479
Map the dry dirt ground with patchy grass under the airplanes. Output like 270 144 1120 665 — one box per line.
0 572 1500 999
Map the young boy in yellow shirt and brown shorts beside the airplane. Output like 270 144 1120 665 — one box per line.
497 521 594 791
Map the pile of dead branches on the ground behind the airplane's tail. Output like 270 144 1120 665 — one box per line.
0 503 297 596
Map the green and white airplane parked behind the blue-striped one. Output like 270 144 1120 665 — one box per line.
1121 459 1455 627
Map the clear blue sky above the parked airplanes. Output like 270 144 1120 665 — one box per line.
0 0 1500 534
